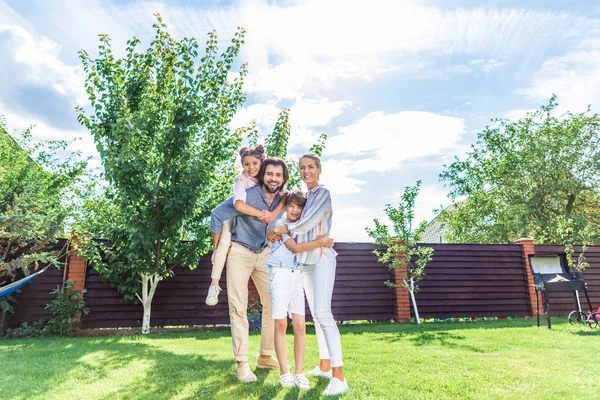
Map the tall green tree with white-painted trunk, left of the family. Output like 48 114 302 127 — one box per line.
78 14 246 333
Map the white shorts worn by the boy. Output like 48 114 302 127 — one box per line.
269 266 304 319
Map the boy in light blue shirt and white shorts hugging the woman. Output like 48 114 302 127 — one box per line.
267 190 333 389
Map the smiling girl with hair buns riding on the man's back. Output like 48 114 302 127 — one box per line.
206 144 283 306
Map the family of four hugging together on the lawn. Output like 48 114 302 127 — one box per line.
206 145 350 396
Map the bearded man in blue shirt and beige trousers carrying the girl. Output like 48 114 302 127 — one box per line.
211 158 289 382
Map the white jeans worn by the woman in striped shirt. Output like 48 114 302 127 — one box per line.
304 250 343 367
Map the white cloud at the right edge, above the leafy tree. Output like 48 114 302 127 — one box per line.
518 39 600 113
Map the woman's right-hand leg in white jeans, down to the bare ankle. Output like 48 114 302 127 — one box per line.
313 254 344 381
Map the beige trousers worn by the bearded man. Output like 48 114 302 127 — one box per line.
227 242 275 361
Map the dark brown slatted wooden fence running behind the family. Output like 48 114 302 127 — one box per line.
8 242 600 329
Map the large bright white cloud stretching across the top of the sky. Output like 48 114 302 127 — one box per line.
236 0 591 99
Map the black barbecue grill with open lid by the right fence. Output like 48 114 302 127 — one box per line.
529 254 593 329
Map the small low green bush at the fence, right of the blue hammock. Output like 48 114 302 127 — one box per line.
46 281 90 336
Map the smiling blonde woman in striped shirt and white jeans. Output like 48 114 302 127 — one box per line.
269 153 350 396
